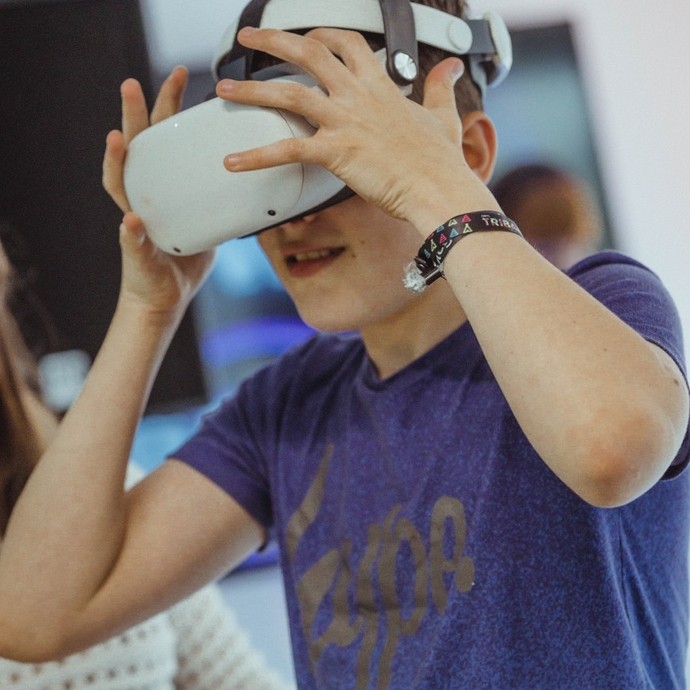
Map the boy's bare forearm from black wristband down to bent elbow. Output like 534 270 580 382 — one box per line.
444 226 687 506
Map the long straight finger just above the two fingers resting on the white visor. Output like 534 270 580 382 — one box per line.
237 27 351 91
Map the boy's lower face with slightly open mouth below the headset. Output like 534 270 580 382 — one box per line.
259 197 422 331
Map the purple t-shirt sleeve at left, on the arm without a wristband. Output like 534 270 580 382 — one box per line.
170 334 354 533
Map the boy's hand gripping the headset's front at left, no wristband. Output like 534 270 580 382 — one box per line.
103 67 214 320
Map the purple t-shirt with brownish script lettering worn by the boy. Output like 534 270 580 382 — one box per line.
174 252 690 690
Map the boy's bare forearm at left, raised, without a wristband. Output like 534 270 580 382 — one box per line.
0 298 177 659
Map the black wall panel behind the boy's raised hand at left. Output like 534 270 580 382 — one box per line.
0 0 204 409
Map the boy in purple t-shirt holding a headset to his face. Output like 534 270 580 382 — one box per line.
0 1 689 689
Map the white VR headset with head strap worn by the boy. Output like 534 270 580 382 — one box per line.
124 0 512 255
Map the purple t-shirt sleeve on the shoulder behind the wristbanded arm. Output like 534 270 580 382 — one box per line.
569 252 690 478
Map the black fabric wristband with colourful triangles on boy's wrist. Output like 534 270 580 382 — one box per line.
403 211 522 293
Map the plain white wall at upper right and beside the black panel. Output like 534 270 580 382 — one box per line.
142 0 690 362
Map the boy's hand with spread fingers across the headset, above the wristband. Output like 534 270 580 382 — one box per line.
217 28 478 222
